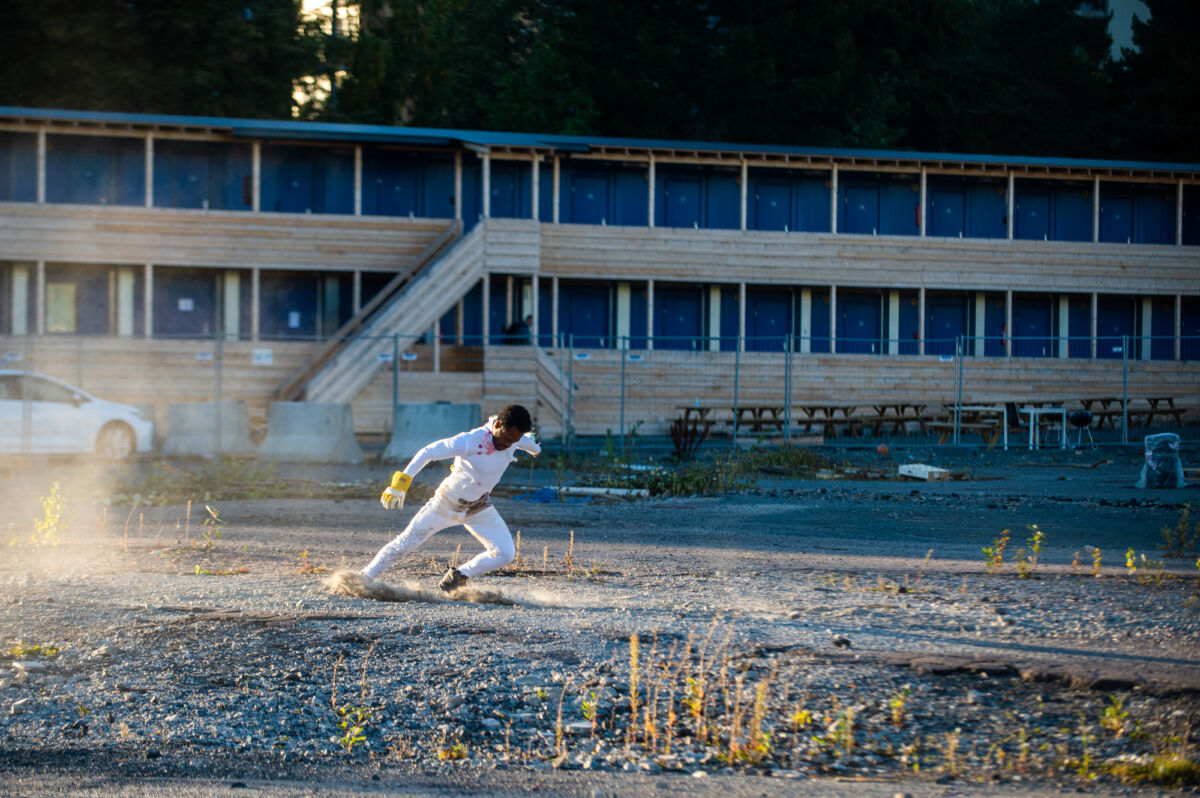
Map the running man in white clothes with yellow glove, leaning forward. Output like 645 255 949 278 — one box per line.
362 404 541 593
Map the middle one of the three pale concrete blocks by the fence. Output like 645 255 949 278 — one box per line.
258 402 362 463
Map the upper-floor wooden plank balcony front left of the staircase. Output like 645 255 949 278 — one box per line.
0 203 450 271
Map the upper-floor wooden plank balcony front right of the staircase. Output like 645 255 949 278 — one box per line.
537 220 1200 294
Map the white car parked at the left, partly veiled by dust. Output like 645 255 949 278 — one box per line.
0 370 154 460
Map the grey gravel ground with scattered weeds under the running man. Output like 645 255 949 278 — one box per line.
0 451 1200 796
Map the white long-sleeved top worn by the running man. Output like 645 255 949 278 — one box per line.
404 416 541 502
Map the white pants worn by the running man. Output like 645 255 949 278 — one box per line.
362 493 516 580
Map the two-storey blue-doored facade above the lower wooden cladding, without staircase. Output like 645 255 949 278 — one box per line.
0 108 1200 432
